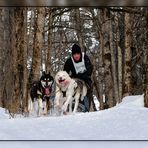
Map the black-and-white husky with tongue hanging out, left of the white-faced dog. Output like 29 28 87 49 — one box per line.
28 72 54 116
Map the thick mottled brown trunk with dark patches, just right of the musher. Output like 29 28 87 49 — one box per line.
102 9 114 107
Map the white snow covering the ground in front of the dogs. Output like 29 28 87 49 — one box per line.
0 95 148 148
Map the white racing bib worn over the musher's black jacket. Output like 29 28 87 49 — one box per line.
71 52 86 74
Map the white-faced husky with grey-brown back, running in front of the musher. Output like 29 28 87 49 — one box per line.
55 71 87 114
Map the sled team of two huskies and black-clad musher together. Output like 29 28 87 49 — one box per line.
28 44 93 116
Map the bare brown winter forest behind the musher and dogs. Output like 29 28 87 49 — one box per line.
0 7 148 114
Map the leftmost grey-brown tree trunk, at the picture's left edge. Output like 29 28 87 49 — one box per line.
1 8 13 108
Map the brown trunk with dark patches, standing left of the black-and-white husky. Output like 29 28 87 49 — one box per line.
10 7 24 114
